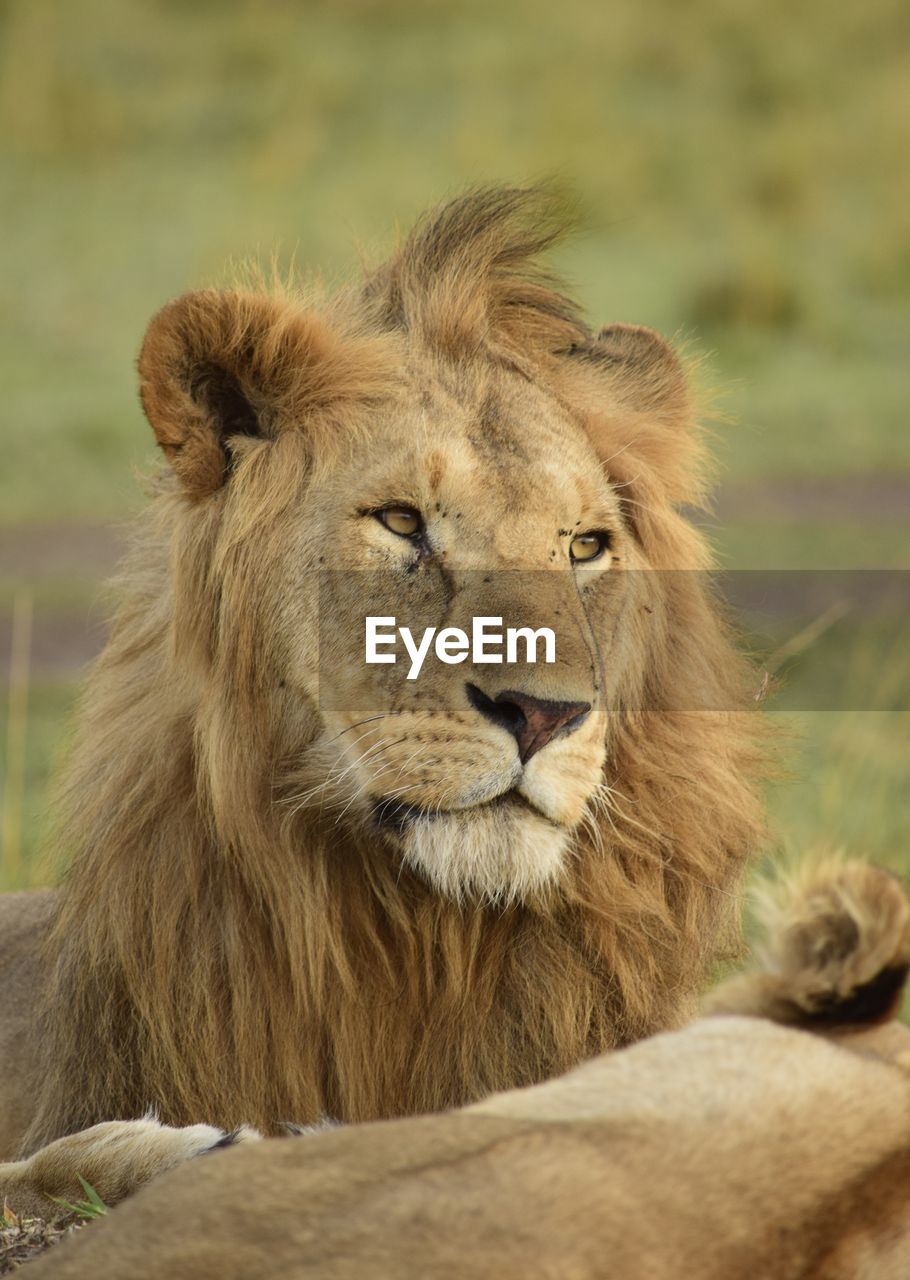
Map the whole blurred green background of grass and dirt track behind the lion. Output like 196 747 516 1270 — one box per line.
0 0 910 887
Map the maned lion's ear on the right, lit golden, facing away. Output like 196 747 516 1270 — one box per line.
567 324 703 503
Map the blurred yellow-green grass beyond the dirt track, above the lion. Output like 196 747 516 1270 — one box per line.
0 0 910 524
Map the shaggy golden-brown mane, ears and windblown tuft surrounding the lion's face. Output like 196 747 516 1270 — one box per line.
27 191 762 1148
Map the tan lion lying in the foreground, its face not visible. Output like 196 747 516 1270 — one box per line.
7 861 910 1280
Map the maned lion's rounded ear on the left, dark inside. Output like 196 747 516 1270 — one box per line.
140 289 366 498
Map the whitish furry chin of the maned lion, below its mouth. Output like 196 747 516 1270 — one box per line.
401 806 570 904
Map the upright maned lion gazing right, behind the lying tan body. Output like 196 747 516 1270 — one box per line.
0 188 765 1155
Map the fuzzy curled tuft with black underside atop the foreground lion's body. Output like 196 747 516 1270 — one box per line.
706 859 910 1029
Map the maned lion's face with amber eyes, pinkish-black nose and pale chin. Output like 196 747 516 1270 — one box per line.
277 361 647 897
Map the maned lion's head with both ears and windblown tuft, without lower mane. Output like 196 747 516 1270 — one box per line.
140 193 742 899
